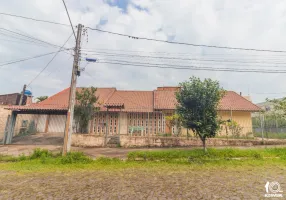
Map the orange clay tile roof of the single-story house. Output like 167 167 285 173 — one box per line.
7 87 260 112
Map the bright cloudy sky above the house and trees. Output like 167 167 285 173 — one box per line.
0 0 286 103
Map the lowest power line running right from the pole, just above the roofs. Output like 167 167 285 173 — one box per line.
95 61 286 74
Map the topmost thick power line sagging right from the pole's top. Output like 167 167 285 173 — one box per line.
87 27 286 53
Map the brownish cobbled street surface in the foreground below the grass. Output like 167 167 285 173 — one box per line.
0 166 286 200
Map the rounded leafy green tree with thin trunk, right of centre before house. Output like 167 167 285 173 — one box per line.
176 77 225 152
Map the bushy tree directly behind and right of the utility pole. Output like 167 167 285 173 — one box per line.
74 87 98 133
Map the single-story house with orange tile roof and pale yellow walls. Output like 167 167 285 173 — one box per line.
4 87 260 141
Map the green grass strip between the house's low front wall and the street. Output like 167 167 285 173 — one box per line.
0 148 286 173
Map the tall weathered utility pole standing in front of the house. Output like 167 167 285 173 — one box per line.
63 24 82 155
